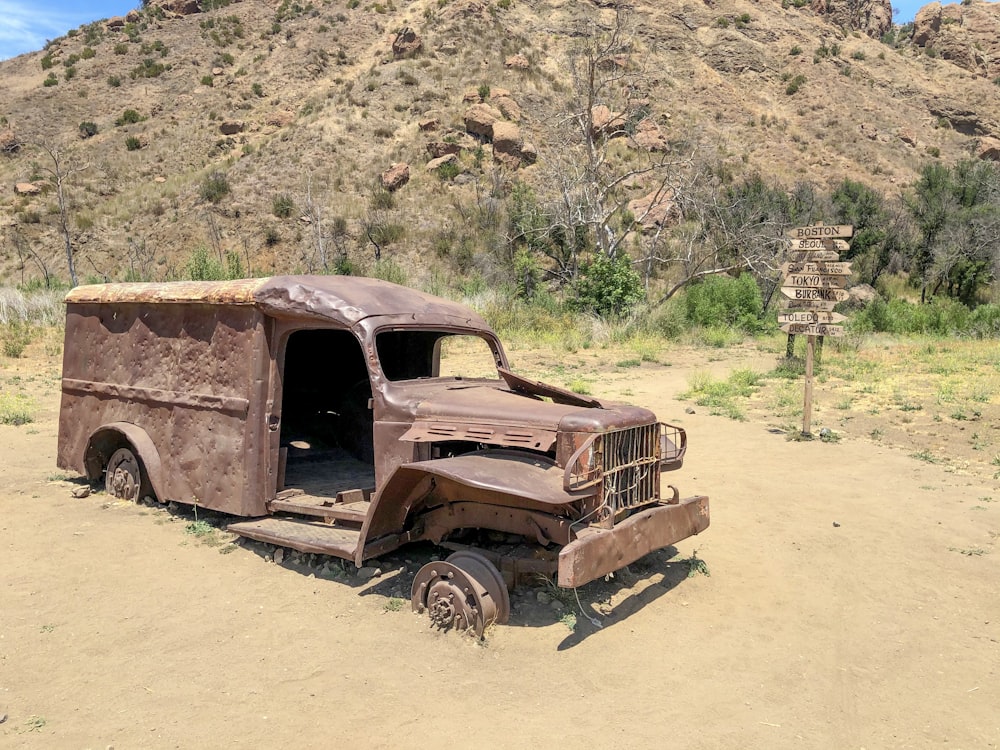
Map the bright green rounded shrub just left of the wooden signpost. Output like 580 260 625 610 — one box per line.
684 273 764 333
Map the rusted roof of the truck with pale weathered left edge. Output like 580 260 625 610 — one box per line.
65 276 488 328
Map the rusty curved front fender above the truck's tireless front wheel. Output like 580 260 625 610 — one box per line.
356 450 593 565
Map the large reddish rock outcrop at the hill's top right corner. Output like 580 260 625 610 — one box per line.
913 2 1000 78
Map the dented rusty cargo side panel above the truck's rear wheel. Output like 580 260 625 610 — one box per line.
58 302 262 514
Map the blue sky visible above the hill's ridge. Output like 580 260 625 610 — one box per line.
0 0 996 60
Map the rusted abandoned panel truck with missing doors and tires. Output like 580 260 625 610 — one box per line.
58 276 709 634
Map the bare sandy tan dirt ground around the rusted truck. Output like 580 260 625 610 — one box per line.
0 342 1000 750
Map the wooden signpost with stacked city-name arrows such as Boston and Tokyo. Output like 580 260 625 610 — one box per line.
778 224 854 437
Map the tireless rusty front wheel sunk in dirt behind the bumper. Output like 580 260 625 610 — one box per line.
410 550 510 638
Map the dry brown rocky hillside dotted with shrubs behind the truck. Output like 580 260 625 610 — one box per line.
0 0 1000 290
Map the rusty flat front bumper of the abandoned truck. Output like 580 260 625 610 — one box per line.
559 495 709 588
